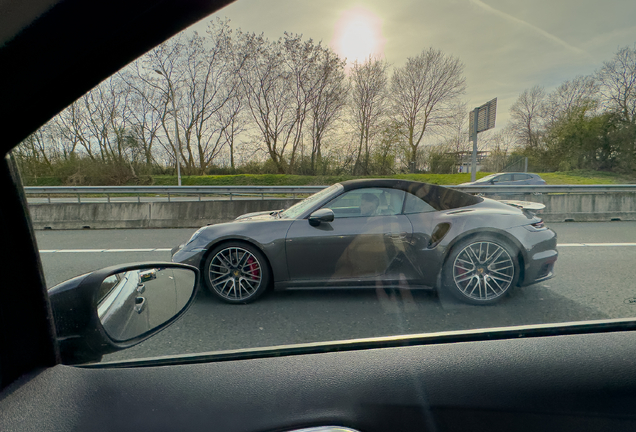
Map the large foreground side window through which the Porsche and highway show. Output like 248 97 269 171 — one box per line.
13 0 636 362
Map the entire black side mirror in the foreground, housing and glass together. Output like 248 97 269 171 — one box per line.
49 263 199 364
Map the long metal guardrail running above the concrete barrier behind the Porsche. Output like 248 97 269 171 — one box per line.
24 184 636 202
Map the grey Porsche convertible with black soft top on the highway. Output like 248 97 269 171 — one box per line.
172 179 557 305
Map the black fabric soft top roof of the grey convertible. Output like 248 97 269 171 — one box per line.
340 179 483 210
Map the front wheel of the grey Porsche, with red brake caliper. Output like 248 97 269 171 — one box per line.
201 242 271 304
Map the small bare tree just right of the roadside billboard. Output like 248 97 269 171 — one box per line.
510 86 546 148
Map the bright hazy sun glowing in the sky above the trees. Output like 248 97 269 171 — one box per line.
331 6 386 65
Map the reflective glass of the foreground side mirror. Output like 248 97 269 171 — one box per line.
97 267 196 342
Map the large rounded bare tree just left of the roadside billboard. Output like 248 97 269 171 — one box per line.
391 48 466 168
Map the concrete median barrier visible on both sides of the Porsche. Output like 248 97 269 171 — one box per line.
29 193 636 229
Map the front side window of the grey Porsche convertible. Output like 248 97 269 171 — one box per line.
323 188 404 218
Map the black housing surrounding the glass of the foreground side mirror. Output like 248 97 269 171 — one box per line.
48 262 199 364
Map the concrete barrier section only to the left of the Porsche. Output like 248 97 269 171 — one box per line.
29 199 298 229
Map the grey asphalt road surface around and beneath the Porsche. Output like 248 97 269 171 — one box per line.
36 222 636 360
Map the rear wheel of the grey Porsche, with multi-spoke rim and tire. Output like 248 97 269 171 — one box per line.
442 235 519 305
